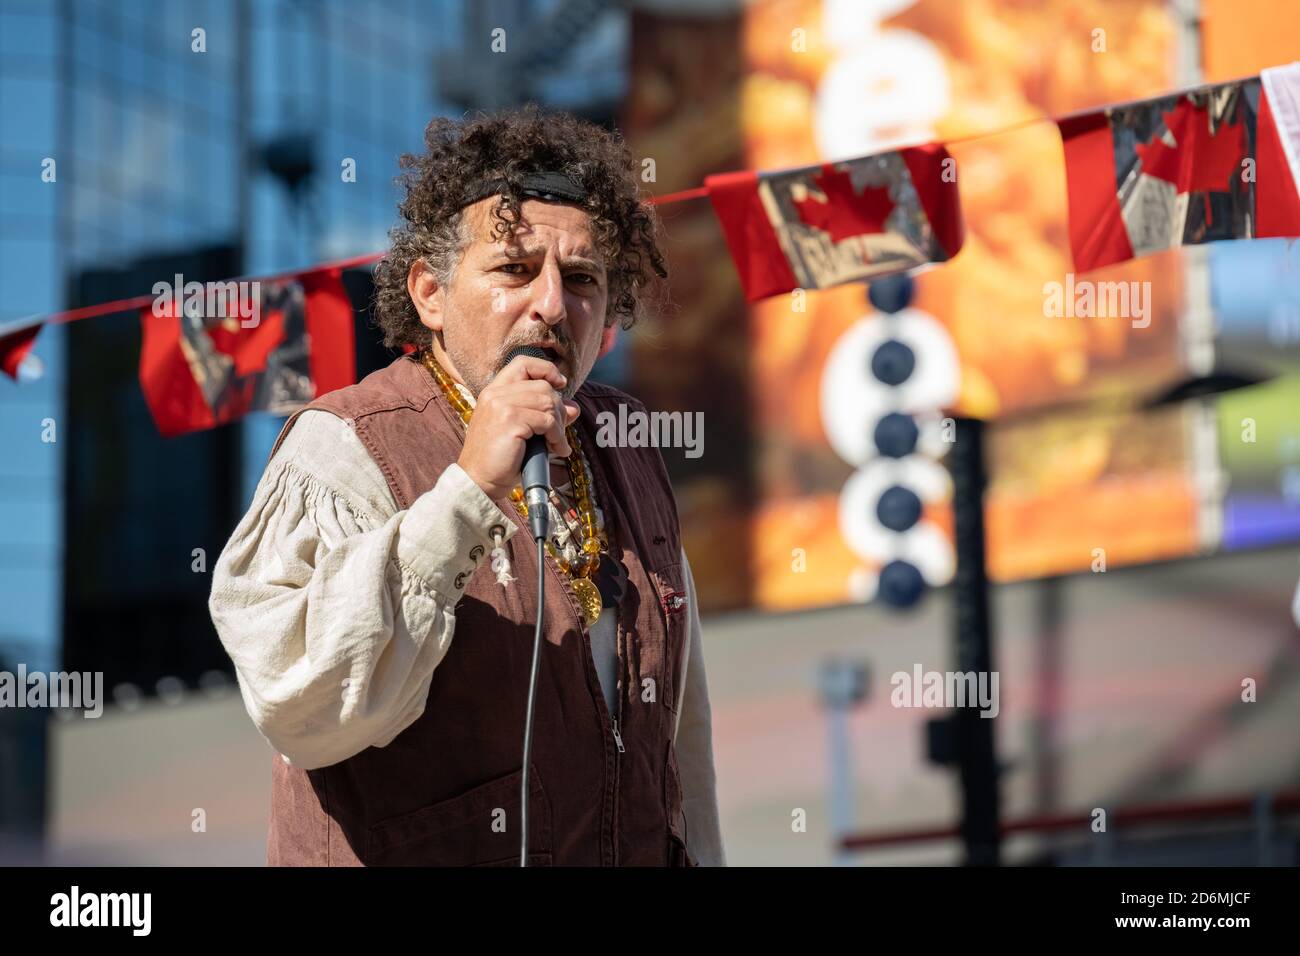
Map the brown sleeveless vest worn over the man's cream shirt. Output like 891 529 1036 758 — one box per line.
258 356 696 866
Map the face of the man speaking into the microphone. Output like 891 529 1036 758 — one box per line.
407 196 608 398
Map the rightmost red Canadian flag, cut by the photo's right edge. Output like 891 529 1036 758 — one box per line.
1058 64 1300 272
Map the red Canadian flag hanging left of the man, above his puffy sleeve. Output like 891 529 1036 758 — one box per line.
140 268 356 437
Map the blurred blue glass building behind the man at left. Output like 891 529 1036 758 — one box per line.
0 0 627 853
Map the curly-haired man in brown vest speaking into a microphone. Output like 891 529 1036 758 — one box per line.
209 107 725 866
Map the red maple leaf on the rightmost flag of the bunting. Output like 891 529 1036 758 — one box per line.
1136 99 1245 193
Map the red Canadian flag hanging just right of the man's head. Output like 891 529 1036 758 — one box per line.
705 143 962 302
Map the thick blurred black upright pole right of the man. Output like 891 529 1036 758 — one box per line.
949 419 1000 866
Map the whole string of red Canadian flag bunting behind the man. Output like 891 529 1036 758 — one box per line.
0 62 1300 436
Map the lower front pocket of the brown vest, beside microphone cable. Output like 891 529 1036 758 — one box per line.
365 763 553 866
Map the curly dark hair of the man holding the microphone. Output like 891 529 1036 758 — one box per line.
374 104 668 349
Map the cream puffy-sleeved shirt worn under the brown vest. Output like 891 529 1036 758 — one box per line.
208 410 725 866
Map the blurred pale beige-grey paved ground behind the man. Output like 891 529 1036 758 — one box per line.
38 549 1300 865
